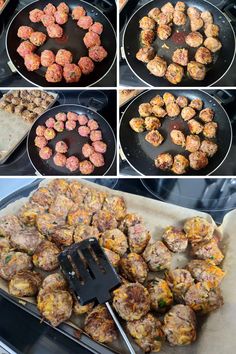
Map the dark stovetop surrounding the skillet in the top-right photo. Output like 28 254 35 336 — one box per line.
120 0 236 87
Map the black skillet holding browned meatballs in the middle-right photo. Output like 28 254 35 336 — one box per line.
120 90 232 176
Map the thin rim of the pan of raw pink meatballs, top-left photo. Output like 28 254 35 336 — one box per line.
5 0 117 90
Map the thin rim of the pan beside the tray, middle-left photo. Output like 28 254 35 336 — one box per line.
26 103 117 178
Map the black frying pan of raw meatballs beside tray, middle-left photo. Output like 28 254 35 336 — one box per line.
27 104 116 176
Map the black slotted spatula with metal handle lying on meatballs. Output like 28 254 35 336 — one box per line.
58 238 135 354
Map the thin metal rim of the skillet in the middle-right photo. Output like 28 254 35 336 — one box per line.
119 88 233 178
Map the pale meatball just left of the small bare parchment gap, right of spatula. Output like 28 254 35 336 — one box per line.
143 241 172 272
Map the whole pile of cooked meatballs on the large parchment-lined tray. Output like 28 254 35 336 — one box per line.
0 179 224 352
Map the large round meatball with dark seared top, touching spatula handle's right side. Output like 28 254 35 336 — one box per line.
113 283 150 321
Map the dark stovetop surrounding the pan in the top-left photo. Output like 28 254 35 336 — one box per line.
0 0 117 87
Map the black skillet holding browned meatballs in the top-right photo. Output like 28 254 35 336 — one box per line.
123 0 236 87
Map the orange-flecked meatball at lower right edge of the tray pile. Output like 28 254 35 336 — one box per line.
184 282 224 314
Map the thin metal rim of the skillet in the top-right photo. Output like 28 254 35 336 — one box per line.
122 0 236 88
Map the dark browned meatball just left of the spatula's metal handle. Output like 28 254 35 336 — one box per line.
84 305 117 343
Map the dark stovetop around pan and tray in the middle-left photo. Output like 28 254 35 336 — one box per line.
0 90 116 176
